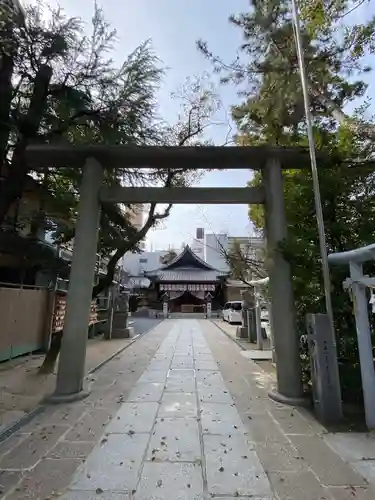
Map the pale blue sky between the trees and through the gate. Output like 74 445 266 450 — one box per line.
24 0 374 250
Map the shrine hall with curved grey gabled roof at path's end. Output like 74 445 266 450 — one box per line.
145 246 227 312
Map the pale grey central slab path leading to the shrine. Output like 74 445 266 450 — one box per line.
63 320 273 500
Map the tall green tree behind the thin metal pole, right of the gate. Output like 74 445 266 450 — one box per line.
200 0 375 401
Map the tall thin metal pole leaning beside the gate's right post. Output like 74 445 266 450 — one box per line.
292 0 336 336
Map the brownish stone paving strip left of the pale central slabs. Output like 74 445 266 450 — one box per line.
0 324 167 500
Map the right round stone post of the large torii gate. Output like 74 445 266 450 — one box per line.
262 158 305 405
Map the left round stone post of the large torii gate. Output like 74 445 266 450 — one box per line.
50 158 104 403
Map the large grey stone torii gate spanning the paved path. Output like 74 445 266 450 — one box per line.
26 144 310 405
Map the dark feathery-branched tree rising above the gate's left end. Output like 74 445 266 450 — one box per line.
0 3 163 223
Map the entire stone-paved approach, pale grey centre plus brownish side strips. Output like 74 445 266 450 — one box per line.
0 320 375 500
